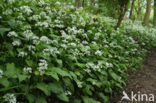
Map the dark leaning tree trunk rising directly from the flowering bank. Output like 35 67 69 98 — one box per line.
115 0 129 29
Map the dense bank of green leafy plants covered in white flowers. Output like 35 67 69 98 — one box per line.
0 0 156 103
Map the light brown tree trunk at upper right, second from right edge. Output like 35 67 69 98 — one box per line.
142 0 151 25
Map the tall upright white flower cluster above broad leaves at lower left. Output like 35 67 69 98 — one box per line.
37 59 48 75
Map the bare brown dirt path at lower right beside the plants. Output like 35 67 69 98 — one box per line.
111 49 156 103
